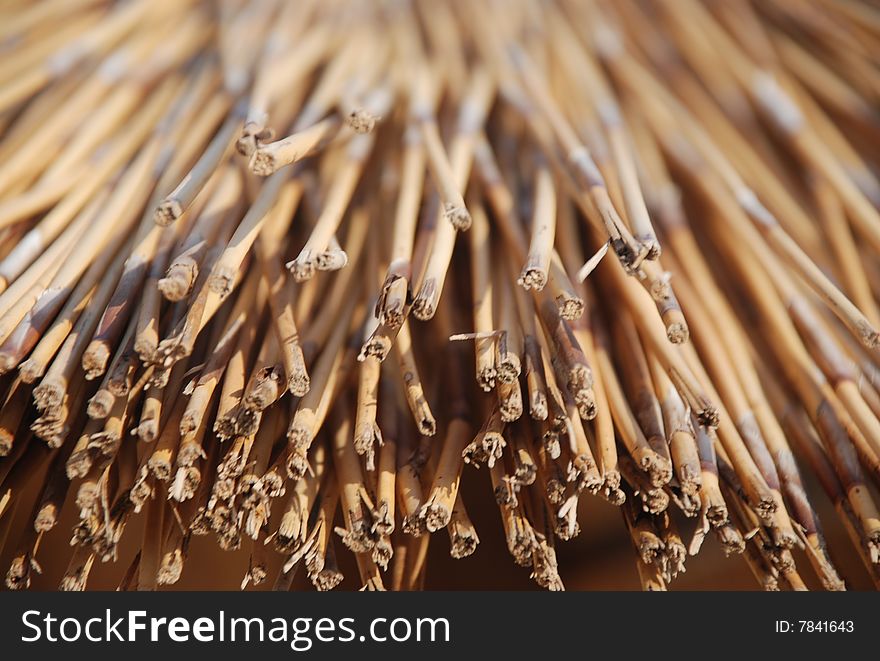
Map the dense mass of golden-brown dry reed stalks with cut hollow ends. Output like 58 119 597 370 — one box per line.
0 0 880 590
